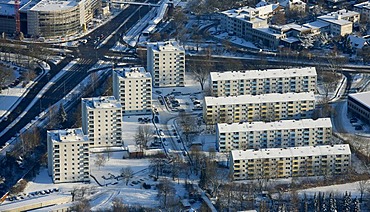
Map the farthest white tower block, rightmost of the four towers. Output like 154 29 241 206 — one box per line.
147 40 185 87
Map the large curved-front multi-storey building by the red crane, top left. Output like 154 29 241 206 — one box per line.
0 0 99 38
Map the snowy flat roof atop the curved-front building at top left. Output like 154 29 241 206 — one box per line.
30 0 79 12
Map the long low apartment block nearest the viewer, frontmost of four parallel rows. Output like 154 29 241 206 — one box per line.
230 144 351 180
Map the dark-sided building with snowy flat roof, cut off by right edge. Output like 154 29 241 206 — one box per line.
347 91 370 123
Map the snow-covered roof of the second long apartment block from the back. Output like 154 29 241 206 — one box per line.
204 92 315 106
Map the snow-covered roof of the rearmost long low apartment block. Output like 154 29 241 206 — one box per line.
210 67 317 81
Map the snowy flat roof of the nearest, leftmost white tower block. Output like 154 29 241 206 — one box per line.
48 128 89 142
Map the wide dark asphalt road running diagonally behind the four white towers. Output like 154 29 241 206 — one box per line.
0 5 150 146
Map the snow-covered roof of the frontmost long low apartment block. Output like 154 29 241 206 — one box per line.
231 144 351 160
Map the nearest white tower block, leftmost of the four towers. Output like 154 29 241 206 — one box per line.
47 128 90 183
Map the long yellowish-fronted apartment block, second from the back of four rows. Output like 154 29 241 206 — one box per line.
203 92 315 125
